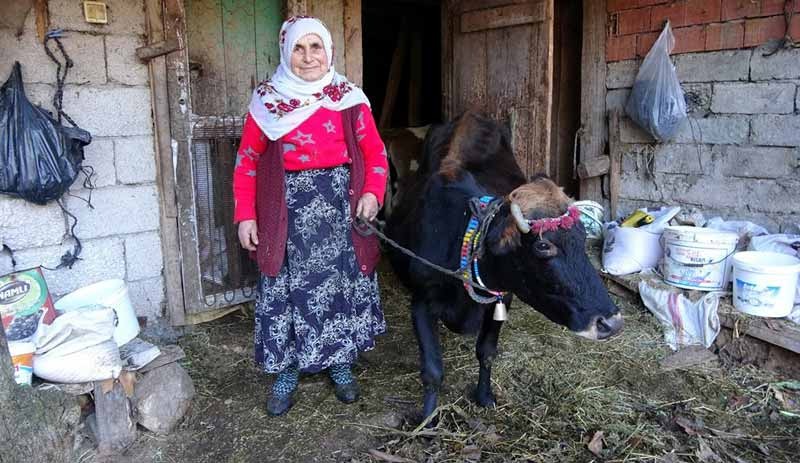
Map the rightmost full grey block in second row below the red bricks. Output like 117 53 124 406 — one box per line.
711 82 800 114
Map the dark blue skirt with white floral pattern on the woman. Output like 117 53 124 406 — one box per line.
255 166 386 373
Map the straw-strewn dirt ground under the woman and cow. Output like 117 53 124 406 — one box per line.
98 260 800 463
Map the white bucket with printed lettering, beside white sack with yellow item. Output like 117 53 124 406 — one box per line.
661 225 739 291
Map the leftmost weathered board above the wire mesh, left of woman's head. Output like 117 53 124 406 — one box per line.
185 0 228 116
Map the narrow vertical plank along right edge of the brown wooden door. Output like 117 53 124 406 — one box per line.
526 0 554 175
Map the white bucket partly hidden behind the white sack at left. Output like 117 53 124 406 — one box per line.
55 279 139 346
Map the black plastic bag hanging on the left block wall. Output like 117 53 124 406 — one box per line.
0 62 92 204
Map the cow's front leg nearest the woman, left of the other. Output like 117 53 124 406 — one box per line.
411 301 444 419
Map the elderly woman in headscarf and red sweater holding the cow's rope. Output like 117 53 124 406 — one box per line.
233 17 387 416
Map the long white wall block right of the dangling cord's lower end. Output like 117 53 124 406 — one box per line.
67 185 158 238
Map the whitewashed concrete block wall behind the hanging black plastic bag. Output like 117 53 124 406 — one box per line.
0 0 165 318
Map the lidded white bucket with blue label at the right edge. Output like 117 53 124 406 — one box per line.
733 251 800 317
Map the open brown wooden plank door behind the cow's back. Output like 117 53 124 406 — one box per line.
442 0 553 176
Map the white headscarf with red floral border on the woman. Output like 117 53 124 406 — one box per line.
250 16 369 141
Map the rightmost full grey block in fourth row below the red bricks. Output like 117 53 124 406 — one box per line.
713 145 797 178
